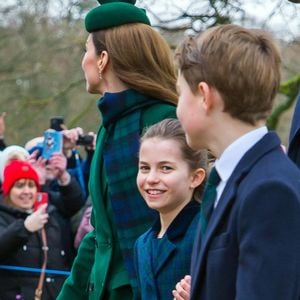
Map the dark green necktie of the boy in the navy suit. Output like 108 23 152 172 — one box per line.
200 167 221 237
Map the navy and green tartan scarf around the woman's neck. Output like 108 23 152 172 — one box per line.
99 90 170 287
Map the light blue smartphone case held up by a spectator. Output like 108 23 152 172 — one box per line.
42 130 63 160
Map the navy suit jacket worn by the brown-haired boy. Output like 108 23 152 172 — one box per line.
191 133 300 300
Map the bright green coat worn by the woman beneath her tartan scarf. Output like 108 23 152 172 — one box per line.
57 98 176 300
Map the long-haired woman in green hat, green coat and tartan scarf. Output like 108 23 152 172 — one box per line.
58 0 177 300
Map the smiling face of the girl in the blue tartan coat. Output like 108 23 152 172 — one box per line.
137 137 195 215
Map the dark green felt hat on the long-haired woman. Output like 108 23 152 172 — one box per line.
85 0 151 32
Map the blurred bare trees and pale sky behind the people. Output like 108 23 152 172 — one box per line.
0 0 300 145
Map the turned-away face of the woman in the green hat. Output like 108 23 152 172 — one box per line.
81 35 100 94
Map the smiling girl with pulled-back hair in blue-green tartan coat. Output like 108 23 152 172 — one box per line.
135 119 207 300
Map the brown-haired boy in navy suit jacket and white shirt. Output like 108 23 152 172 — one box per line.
174 25 300 300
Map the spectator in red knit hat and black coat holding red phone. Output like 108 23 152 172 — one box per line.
0 160 74 299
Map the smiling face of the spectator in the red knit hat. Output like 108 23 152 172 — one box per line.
9 179 37 210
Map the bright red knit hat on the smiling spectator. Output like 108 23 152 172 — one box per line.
2 160 40 196
